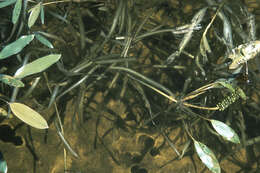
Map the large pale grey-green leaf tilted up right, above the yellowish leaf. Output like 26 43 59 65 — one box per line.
15 54 61 79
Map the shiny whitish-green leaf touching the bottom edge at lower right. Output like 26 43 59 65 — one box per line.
194 141 221 173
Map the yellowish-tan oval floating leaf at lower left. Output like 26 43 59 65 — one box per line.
8 102 49 129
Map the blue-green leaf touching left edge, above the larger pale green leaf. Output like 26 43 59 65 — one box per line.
0 35 34 59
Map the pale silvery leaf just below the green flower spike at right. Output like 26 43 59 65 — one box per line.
210 120 240 144
